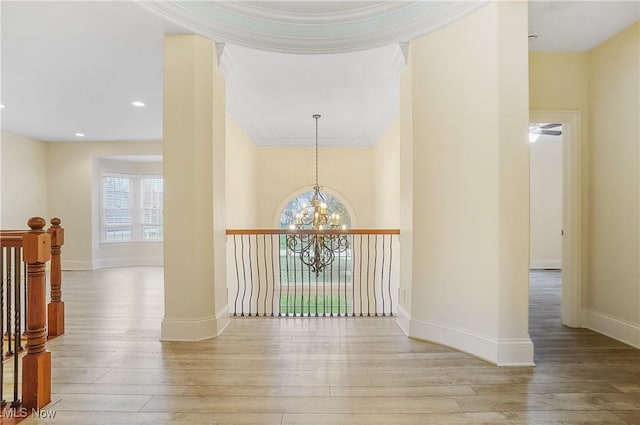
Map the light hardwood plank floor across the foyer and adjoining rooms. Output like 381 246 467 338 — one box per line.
22 268 640 425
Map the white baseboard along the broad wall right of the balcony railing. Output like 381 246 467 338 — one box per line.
409 318 535 366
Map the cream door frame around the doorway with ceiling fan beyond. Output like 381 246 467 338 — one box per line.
529 110 583 328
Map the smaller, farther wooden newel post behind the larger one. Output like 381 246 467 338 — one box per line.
47 217 64 337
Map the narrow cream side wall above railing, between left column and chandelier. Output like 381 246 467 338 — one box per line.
226 115 258 229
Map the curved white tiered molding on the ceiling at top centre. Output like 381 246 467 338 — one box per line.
137 0 487 54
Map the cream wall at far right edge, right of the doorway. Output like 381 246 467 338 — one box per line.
587 22 640 347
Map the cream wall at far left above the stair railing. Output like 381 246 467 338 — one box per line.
0 130 51 229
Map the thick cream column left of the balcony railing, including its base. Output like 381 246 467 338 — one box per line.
161 34 229 341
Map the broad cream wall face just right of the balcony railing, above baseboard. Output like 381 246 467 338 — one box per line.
411 3 499 342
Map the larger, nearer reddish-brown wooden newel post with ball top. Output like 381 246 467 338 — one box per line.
22 217 51 409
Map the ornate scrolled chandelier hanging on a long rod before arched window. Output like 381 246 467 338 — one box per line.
287 114 349 276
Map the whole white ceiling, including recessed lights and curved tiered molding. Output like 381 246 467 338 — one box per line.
0 0 640 146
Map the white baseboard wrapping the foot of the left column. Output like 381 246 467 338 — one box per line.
160 307 230 342
